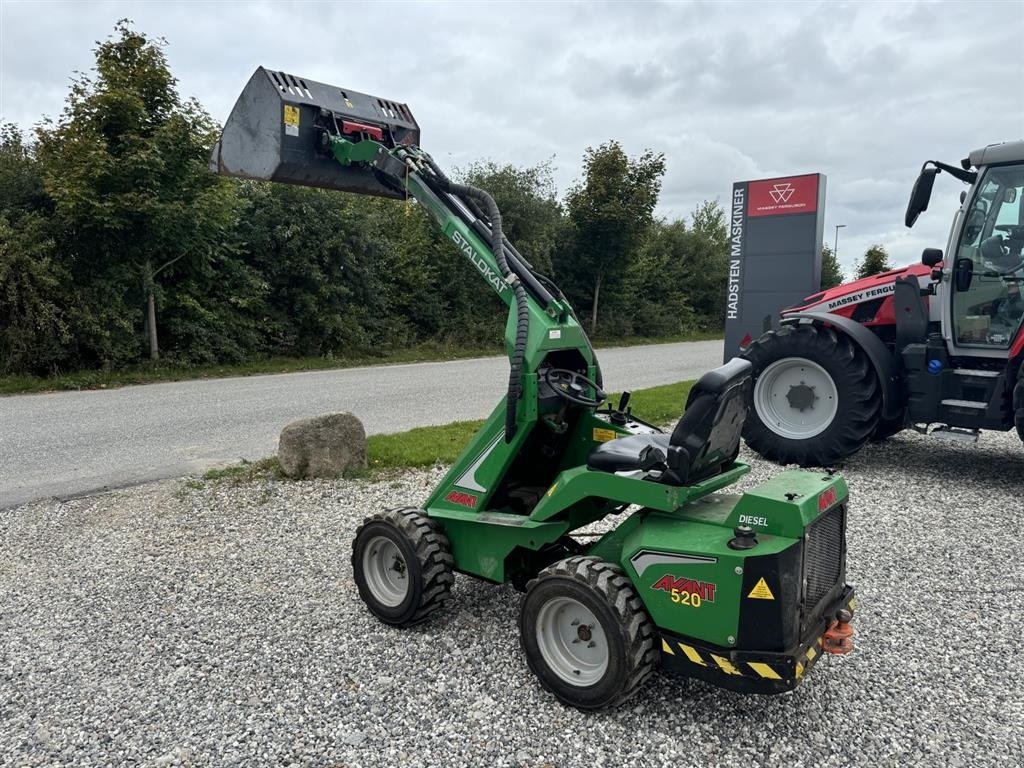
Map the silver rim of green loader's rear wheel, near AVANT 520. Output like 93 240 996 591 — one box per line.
537 597 608 687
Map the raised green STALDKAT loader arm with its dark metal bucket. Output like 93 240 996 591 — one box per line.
210 67 602 443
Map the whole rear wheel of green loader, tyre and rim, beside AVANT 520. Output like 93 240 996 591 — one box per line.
519 557 657 710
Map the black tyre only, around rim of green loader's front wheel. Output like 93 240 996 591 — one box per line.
352 507 455 627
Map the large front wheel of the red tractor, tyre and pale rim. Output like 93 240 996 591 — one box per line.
743 325 882 467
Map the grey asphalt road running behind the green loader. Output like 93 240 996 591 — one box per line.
0 341 722 509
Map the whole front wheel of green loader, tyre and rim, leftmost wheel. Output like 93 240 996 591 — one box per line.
352 509 455 627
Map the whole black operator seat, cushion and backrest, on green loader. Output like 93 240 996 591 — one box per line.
587 357 752 485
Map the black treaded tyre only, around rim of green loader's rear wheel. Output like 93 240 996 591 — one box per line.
519 556 658 711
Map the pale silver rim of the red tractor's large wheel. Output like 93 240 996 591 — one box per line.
754 357 839 440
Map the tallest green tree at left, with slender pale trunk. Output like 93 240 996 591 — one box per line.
37 20 237 361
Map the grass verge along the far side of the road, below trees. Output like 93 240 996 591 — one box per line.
0 331 722 395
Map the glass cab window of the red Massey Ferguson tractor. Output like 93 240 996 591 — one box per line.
953 165 1024 348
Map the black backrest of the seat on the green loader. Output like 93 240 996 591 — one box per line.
669 357 752 482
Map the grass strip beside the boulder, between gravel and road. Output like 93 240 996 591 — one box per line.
203 381 693 482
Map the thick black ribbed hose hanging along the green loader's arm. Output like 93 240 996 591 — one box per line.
426 156 529 442
